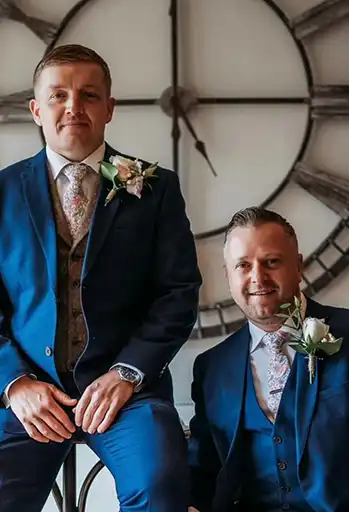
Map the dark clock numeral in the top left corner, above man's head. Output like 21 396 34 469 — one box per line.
0 0 58 44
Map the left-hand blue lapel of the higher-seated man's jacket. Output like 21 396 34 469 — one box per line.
21 149 57 290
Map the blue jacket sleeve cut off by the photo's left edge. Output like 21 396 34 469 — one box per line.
0 277 33 408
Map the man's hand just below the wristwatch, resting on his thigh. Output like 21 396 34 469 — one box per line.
75 370 134 434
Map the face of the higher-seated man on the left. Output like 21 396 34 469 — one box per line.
30 62 114 161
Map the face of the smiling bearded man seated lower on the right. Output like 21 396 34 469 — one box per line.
225 222 302 330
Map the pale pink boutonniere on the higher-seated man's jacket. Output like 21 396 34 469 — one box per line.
100 155 158 206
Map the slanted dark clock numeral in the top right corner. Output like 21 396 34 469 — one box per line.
292 0 349 39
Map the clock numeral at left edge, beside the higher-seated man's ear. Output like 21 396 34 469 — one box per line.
0 89 34 124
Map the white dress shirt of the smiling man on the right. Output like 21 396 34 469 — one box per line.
248 294 307 421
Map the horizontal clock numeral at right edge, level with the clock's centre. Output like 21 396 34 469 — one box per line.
311 85 349 119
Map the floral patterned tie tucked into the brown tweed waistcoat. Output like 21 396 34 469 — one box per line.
62 164 90 240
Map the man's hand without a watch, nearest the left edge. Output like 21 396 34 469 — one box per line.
8 376 77 443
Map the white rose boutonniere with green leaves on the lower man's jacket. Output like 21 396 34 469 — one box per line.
278 297 343 384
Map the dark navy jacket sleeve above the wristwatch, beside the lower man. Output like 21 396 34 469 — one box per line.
114 172 201 383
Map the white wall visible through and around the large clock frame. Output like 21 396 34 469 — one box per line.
0 0 349 512
